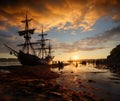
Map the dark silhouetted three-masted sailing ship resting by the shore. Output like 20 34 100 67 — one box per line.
4 14 54 65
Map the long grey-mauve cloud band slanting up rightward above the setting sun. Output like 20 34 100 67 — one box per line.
53 25 120 52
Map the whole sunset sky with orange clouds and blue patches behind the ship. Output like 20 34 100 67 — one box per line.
0 0 120 60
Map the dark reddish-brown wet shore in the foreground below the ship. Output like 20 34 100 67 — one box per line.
0 65 104 101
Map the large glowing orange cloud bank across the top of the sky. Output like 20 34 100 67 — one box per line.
0 0 120 31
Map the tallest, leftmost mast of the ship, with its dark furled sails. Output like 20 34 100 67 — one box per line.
18 13 35 55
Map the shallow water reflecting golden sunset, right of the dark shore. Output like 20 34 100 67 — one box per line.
52 64 120 101
